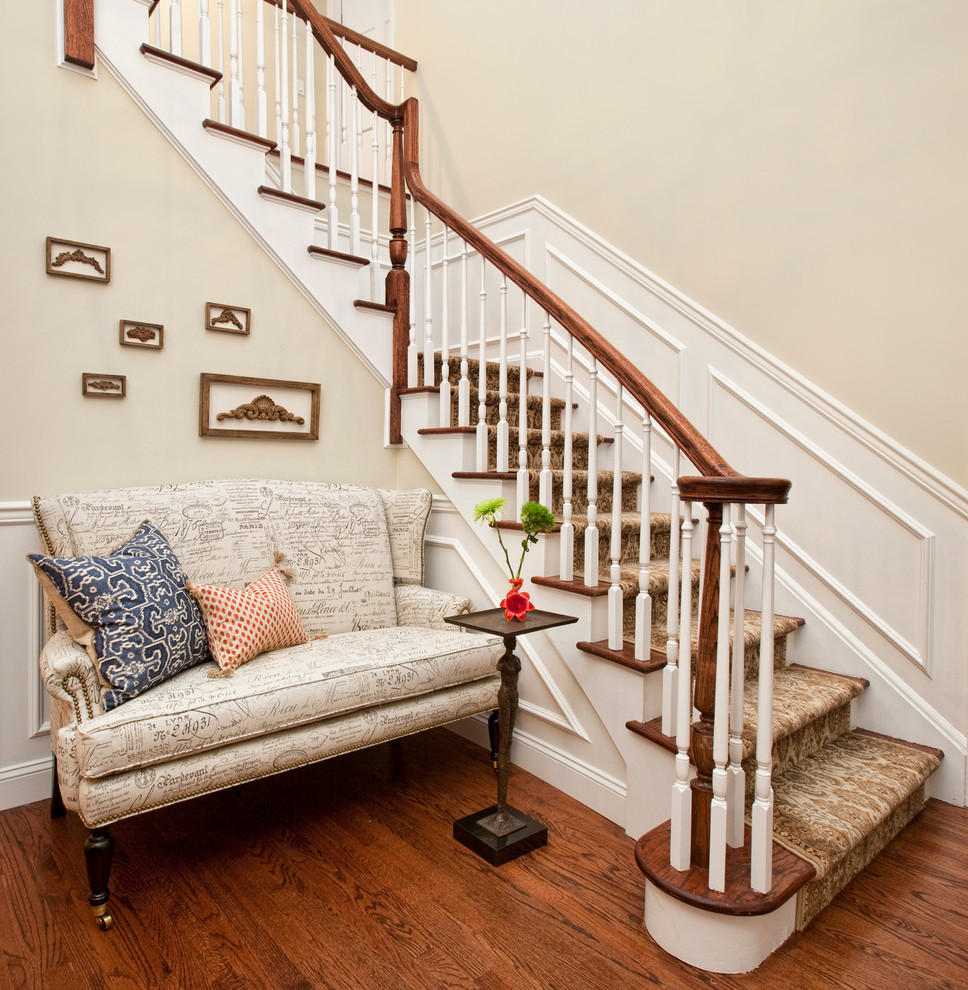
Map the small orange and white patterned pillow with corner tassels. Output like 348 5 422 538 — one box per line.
188 567 309 676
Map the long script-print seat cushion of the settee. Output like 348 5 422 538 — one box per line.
76 626 504 778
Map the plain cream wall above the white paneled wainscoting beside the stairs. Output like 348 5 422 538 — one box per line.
397 0 968 486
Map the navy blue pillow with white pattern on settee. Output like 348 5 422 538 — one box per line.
27 520 210 711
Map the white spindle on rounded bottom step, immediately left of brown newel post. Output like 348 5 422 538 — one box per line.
669 501 692 870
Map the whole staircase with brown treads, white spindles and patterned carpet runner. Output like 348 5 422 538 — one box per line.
83 0 942 972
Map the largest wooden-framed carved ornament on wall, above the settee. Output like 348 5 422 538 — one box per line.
198 372 321 440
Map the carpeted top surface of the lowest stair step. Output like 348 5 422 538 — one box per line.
773 730 941 877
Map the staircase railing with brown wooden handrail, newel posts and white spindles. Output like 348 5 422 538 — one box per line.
104 0 790 912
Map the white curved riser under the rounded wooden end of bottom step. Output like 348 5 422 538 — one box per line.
645 880 797 973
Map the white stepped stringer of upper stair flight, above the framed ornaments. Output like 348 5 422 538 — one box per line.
95 0 392 387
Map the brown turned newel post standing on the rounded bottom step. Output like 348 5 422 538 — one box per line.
686 502 723 869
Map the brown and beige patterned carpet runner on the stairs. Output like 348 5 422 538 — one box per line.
420 357 942 928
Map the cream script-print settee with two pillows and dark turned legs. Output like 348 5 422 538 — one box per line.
28 479 503 928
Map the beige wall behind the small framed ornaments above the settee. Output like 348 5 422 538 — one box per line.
0 2 434 501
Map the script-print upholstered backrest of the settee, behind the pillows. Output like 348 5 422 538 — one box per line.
34 479 400 637
